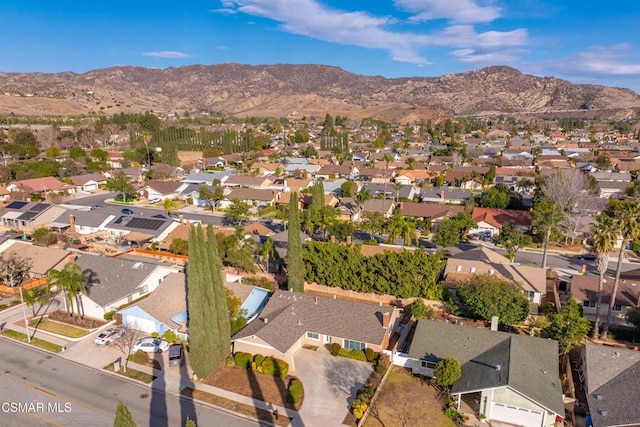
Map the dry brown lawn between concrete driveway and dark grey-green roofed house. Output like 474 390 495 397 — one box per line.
365 366 456 427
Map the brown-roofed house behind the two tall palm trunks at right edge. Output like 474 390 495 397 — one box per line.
569 269 640 326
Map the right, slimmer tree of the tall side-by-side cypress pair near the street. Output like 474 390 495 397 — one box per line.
207 224 231 360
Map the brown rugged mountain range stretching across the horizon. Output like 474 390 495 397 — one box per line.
0 63 640 123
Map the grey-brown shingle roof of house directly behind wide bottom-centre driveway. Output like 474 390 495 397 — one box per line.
233 291 394 353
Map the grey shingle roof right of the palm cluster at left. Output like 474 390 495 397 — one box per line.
76 255 162 307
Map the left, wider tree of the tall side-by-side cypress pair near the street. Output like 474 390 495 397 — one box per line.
187 225 221 378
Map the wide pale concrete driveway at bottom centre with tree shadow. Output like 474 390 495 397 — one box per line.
291 347 373 427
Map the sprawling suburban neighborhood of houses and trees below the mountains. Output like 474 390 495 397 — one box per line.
0 114 640 427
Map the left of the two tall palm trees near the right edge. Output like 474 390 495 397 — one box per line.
591 215 618 338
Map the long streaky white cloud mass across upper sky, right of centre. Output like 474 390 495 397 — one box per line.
223 0 528 64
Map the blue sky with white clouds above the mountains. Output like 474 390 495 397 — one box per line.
0 0 640 92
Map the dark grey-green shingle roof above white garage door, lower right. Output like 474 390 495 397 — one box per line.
409 320 564 416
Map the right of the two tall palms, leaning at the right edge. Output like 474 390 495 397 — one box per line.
602 200 640 338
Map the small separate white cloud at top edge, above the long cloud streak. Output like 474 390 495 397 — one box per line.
394 0 502 23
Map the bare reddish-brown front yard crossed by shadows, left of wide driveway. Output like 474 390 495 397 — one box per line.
204 367 301 410
